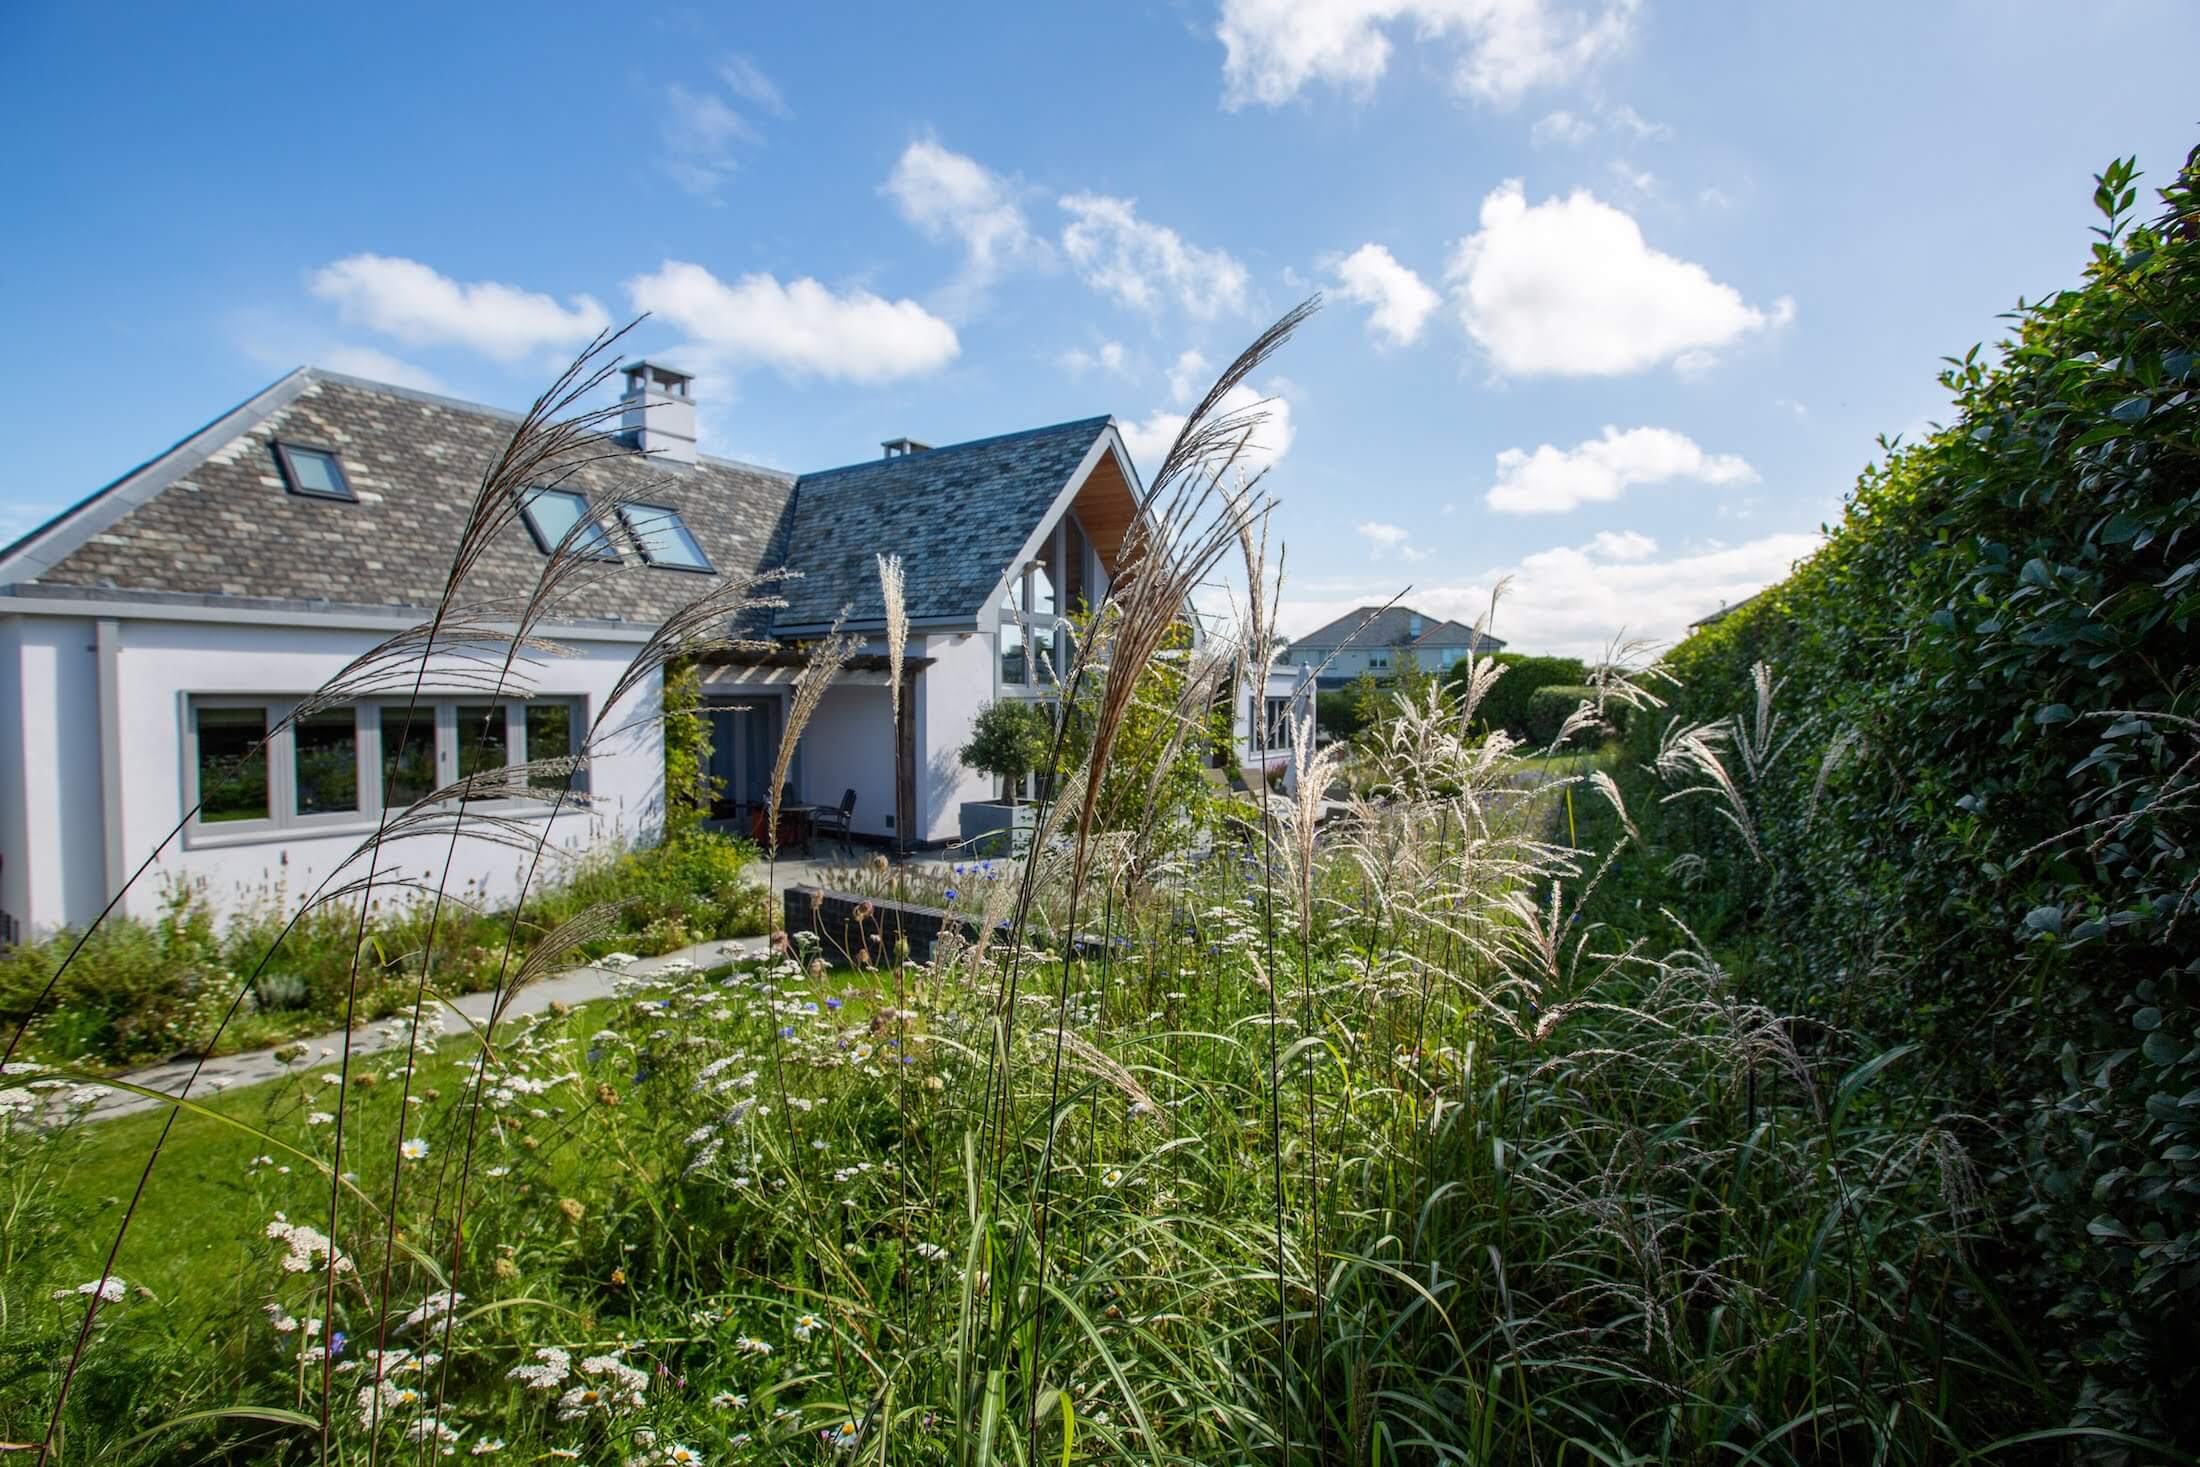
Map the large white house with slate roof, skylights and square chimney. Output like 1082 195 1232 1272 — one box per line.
0 363 1140 930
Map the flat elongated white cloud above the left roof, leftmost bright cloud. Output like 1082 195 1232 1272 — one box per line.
306 255 612 361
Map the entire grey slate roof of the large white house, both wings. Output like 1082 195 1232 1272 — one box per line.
0 367 1135 629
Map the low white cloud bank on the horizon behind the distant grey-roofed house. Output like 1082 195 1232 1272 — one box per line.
1280 534 1822 658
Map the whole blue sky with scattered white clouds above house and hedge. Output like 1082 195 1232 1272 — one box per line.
0 0 2200 651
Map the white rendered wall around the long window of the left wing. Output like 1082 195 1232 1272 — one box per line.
0 616 664 930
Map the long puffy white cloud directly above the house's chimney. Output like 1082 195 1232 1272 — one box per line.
627 260 961 383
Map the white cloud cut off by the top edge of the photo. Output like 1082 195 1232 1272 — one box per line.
1214 0 1637 108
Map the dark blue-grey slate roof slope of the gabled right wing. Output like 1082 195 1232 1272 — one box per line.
777 418 1111 627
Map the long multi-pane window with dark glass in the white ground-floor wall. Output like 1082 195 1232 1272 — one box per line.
183 693 587 845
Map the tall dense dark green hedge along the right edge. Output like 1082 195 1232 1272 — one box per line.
1630 151 2200 1443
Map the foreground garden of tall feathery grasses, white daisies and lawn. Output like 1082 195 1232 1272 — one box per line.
0 312 2035 1467
